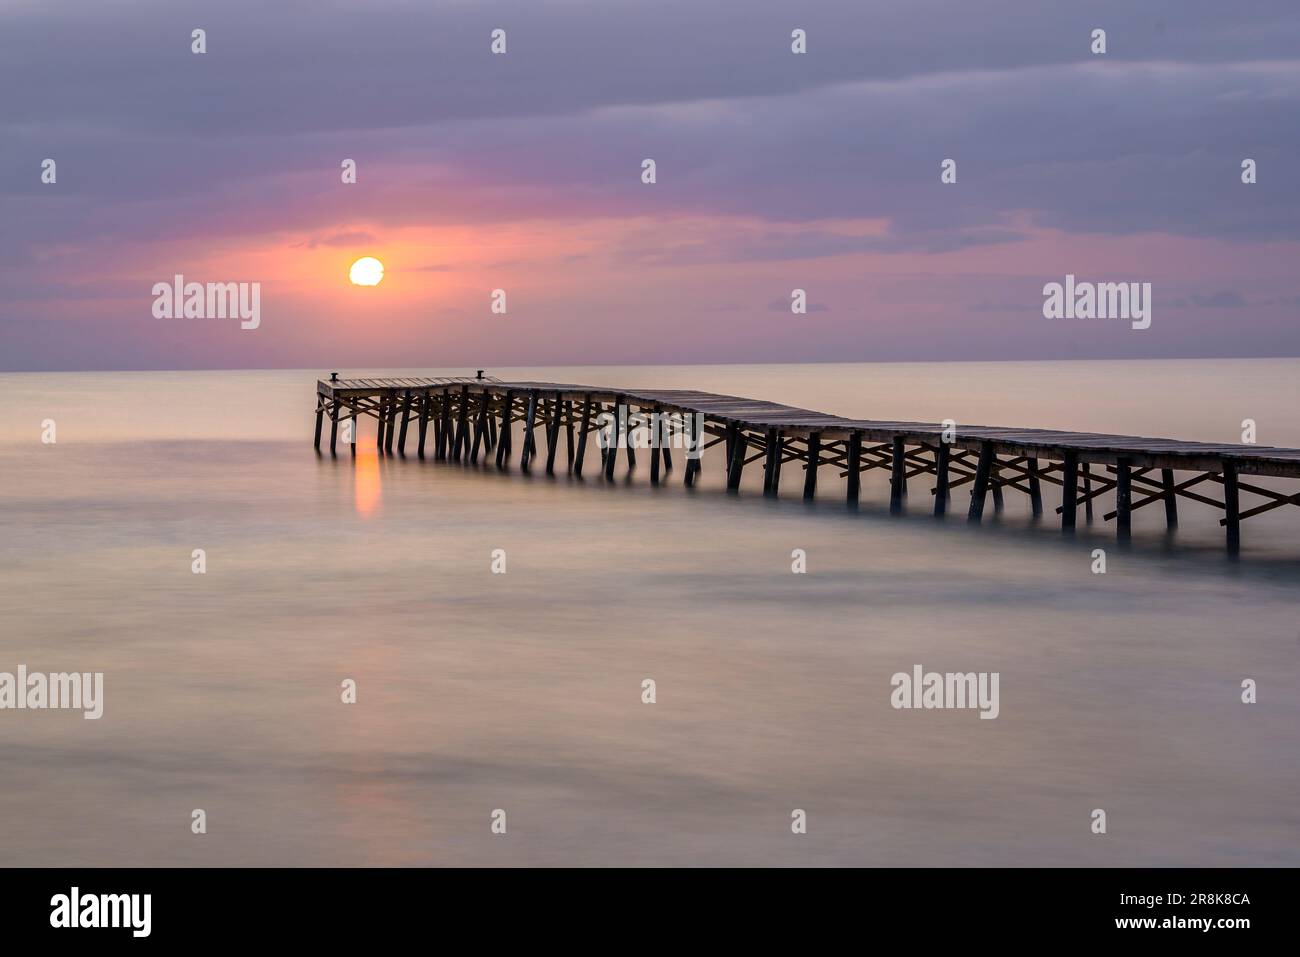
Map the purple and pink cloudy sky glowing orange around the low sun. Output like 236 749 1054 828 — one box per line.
0 0 1300 371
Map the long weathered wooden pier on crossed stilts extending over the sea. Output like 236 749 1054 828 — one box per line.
316 373 1300 554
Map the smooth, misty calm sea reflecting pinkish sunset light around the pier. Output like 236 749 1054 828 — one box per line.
0 360 1300 866
